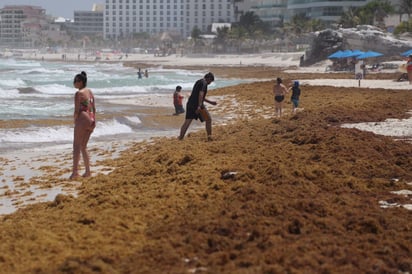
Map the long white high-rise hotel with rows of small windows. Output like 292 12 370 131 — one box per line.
103 0 234 39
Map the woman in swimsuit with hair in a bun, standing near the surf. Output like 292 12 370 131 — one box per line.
70 71 96 179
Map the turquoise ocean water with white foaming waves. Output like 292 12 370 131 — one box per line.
0 59 245 153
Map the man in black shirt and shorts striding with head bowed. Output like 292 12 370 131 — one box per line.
179 72 217 141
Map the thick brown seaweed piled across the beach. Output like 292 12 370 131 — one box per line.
0 55 412 273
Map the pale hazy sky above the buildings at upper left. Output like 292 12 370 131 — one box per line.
0 0 105 19
